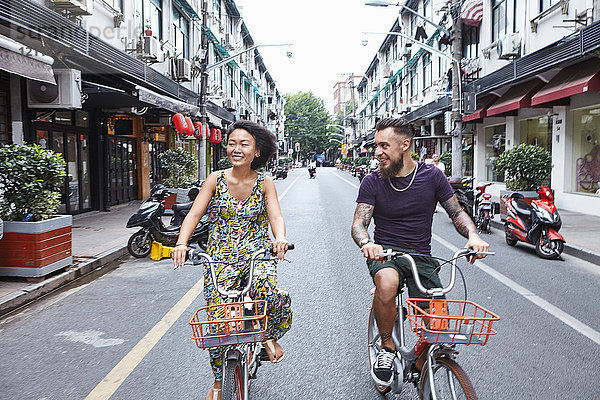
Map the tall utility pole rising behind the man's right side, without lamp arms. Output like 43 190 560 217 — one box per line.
450 0 463 178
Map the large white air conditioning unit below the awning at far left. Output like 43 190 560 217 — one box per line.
27 69 81 109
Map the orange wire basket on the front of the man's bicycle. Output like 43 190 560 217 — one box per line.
406 298 500 346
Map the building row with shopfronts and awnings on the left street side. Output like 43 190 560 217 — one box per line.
0 0 285 214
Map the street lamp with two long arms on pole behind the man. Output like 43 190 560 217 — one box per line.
363 0 462 177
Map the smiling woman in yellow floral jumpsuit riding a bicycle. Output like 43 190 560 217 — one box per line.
171 121 292 400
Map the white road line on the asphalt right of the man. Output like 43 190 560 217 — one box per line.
433 234 600 345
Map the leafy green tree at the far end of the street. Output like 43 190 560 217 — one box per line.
284 92 339 158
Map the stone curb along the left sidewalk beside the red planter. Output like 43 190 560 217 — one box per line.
0 246 127 317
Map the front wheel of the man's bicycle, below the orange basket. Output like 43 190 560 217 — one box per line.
421 357 477 400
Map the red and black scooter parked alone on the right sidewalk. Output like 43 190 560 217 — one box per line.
504 186 565 260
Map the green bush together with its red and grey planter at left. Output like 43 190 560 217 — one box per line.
0 144 73 277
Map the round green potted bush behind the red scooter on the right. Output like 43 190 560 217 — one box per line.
496 143 552 220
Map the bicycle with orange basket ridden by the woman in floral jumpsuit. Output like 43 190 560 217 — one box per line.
183 244 294 400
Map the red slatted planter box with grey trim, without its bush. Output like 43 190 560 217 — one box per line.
0 215 73 277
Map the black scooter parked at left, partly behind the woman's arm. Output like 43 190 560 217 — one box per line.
127 185 208 258
